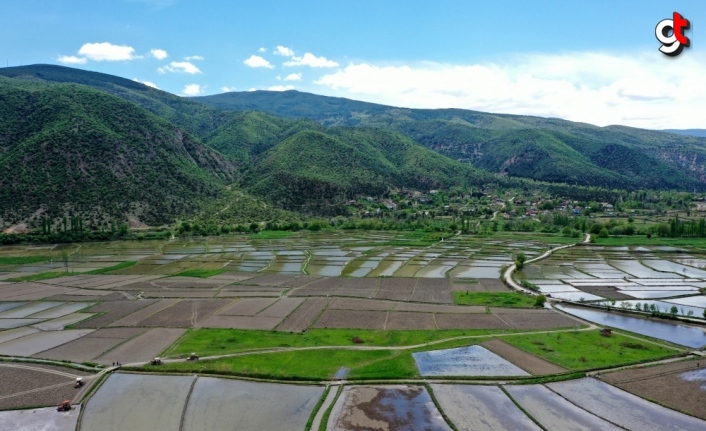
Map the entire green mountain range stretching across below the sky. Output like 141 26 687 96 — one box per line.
0 65 706 227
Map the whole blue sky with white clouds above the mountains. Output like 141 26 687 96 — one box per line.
0 0 706 128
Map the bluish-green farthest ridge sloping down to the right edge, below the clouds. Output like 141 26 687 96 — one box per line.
191 90 706 189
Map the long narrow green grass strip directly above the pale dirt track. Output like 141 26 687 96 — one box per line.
163 328 518 356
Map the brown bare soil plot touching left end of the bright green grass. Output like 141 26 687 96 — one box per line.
96 328 186 364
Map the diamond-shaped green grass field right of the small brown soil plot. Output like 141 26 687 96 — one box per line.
503 330 679 370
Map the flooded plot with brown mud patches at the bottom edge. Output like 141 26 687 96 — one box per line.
327 386 451 431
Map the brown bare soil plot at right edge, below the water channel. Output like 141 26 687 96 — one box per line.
600 358 706 419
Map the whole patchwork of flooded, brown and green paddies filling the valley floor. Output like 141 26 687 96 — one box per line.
0 232 706 431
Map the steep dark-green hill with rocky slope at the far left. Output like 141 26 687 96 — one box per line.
0 77 237 226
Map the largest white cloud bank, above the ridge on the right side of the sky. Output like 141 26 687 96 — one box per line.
316 50 706 129
